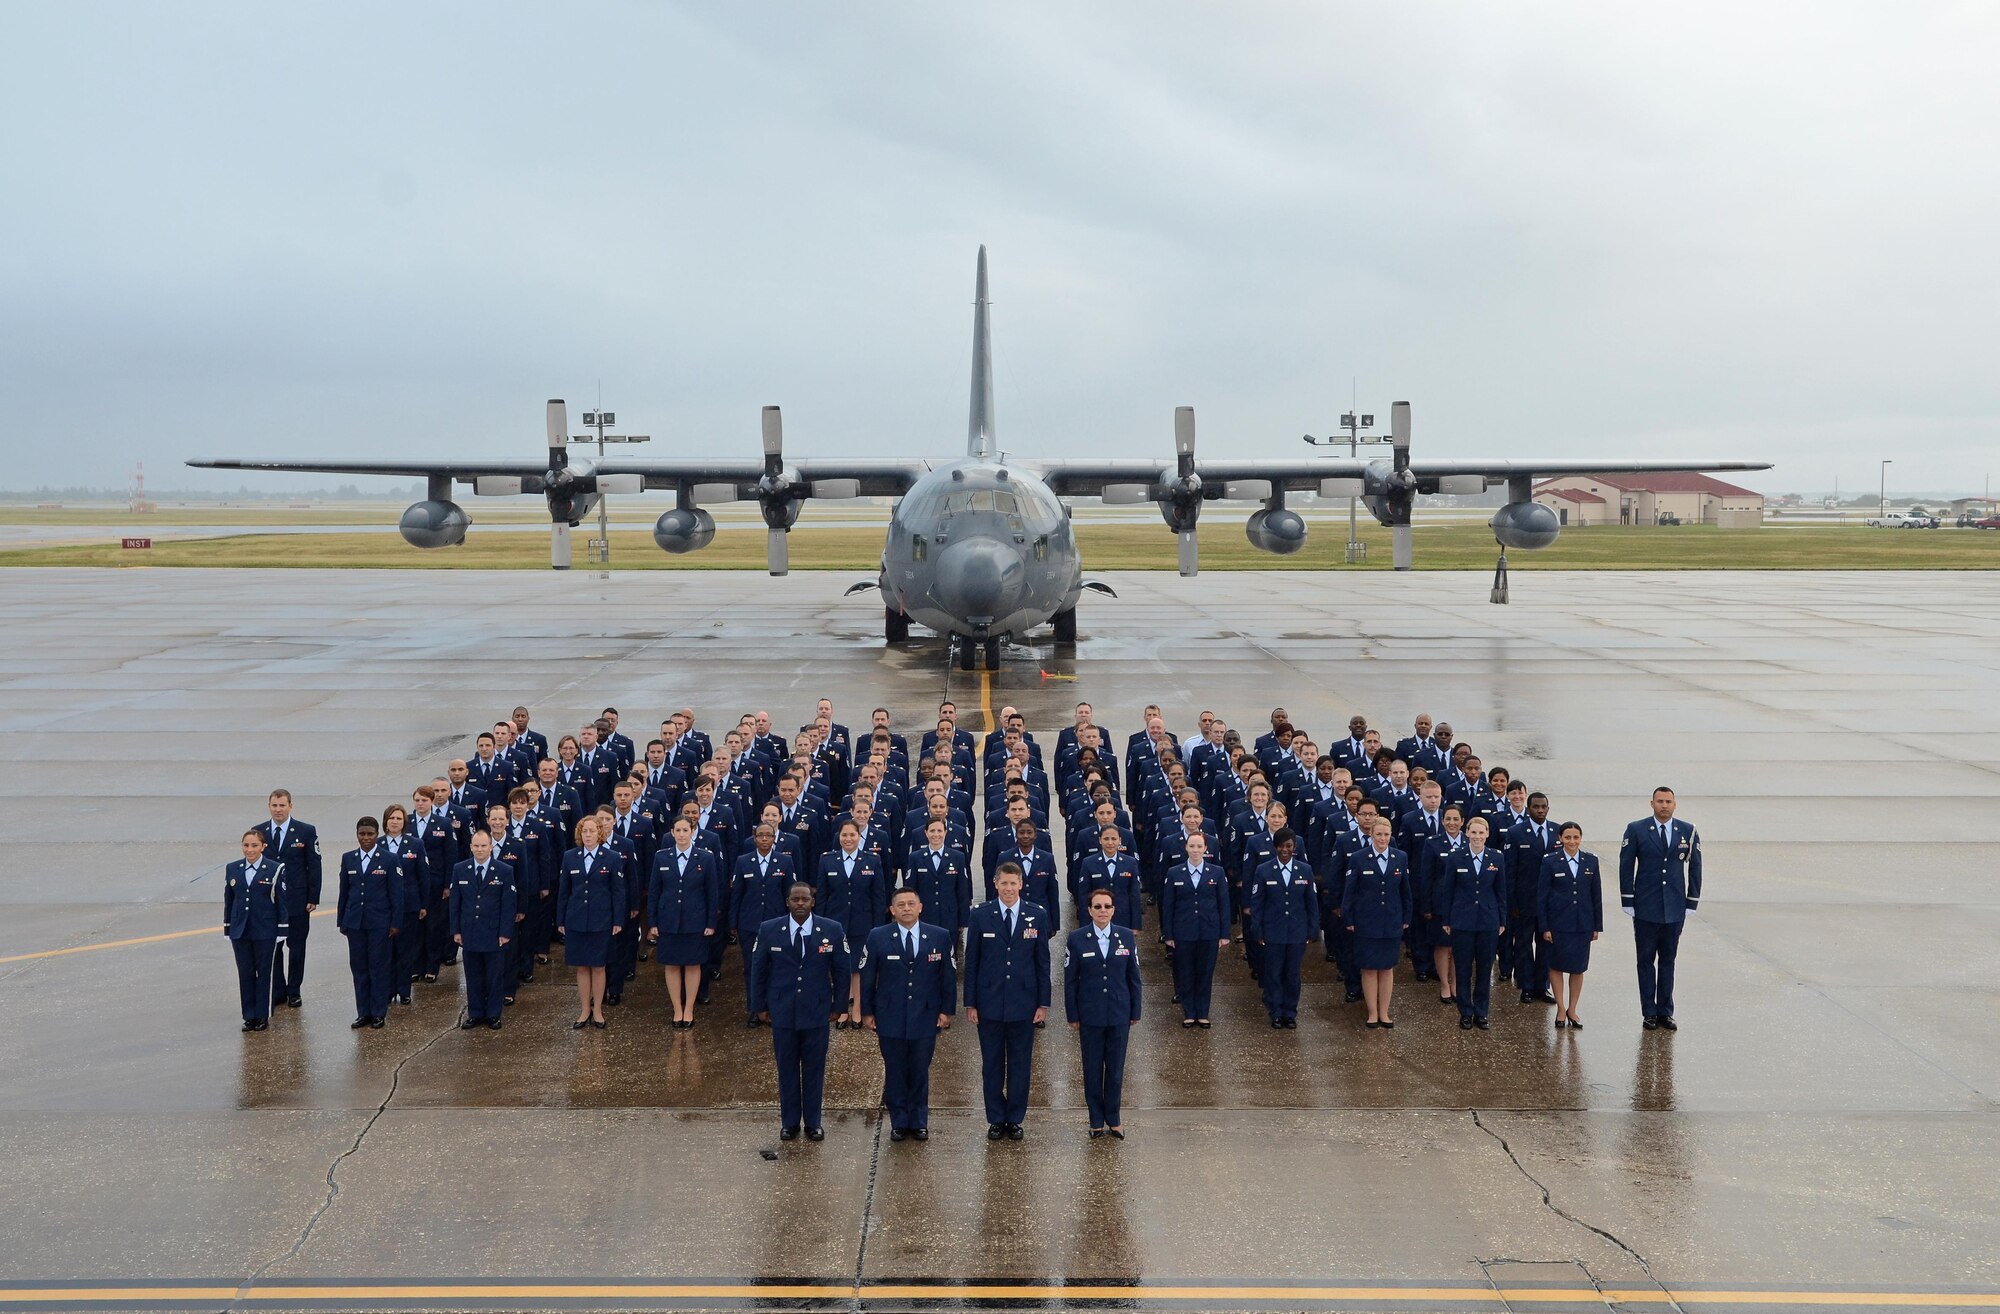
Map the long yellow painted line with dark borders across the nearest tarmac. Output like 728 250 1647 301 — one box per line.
0 1282 2000 1308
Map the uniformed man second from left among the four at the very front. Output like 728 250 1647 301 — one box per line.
860 888 958 1140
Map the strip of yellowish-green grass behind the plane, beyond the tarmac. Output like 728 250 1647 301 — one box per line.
0 520 2000 572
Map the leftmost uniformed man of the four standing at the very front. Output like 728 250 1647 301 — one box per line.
750 880 852 1140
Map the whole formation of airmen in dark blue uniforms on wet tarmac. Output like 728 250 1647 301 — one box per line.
224 698 1702 1140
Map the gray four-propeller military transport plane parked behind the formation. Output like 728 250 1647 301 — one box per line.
188 246 1770 670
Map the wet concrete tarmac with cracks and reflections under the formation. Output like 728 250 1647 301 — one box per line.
0 570 2000 1310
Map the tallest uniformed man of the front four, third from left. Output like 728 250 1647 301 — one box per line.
966 862 1052 1140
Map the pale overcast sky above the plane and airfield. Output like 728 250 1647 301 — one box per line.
0 0 2000 492
